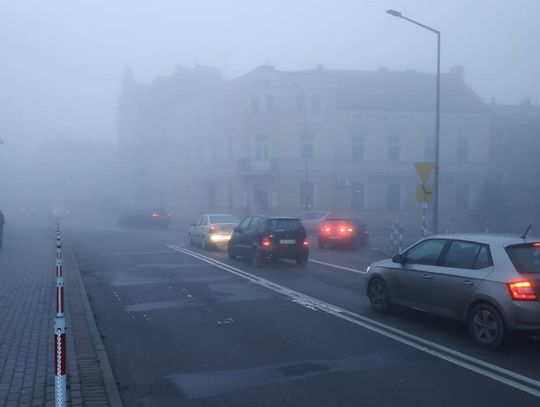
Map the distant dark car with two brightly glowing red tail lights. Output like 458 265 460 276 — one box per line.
317 217 369 249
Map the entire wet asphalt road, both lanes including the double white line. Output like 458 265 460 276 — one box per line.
63 224 540 407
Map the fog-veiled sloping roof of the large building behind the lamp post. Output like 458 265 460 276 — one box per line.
236 65 489 114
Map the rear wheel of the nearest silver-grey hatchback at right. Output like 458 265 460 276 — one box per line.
468 304 506 349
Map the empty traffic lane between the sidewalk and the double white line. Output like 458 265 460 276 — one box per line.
69 231 535 406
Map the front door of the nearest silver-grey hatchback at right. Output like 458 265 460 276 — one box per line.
385 239 448 311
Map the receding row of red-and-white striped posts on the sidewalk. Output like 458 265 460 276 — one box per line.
54 223 67 407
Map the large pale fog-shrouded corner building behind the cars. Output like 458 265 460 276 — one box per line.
119 66 490 229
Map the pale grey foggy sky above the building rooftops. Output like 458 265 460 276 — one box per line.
0 0 540 143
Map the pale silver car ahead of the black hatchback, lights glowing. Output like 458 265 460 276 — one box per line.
188 213 240 249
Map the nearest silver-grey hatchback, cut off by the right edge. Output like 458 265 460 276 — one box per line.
365 234 540 349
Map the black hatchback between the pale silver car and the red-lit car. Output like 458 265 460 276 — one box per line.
227 215 309 267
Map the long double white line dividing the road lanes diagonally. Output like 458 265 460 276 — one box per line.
167 244 540 398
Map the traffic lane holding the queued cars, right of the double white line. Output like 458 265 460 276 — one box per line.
178 245 540 386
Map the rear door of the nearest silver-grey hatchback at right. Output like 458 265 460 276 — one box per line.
433 240 493 319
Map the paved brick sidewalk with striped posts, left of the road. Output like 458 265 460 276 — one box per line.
0 221 121 407
